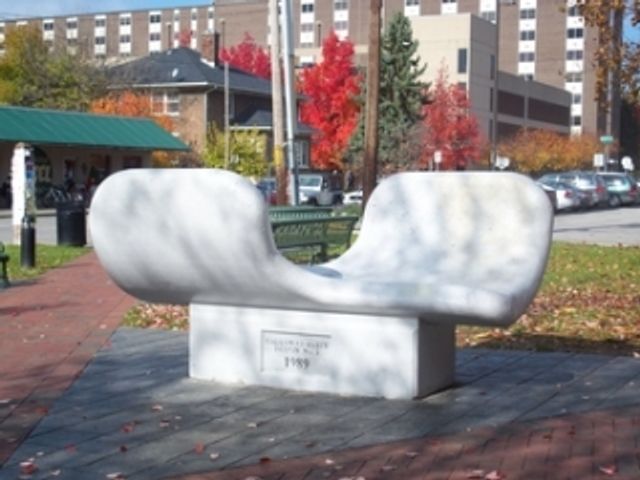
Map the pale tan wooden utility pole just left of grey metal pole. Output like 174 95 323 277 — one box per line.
269 0 287 205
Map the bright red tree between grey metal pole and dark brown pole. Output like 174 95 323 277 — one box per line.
299 32 360 170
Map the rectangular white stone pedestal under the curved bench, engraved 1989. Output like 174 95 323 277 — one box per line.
189 304 455 399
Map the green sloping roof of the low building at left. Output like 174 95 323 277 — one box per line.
0 106 189 150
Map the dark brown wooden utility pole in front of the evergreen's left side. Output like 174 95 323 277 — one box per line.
362 0 382 207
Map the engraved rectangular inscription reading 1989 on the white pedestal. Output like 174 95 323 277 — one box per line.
261 330 331 375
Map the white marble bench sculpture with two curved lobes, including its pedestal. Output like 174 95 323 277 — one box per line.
90 169 553 398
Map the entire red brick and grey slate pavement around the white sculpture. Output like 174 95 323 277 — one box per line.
0 254 640 480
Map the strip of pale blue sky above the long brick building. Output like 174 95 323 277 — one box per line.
0 0 211 19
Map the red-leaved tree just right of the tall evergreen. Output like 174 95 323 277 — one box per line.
420 67 483 170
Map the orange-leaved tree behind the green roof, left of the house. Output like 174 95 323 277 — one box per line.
89 90 174 167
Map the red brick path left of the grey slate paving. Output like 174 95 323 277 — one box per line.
0 254 134 464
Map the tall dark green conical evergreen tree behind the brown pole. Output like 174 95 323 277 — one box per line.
350 13 429 170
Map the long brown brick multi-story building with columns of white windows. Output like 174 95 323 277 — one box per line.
0 0 620 144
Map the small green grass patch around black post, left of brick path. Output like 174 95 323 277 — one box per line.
5 245 90 282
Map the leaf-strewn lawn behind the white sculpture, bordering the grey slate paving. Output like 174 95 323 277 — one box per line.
125 243 640 355
